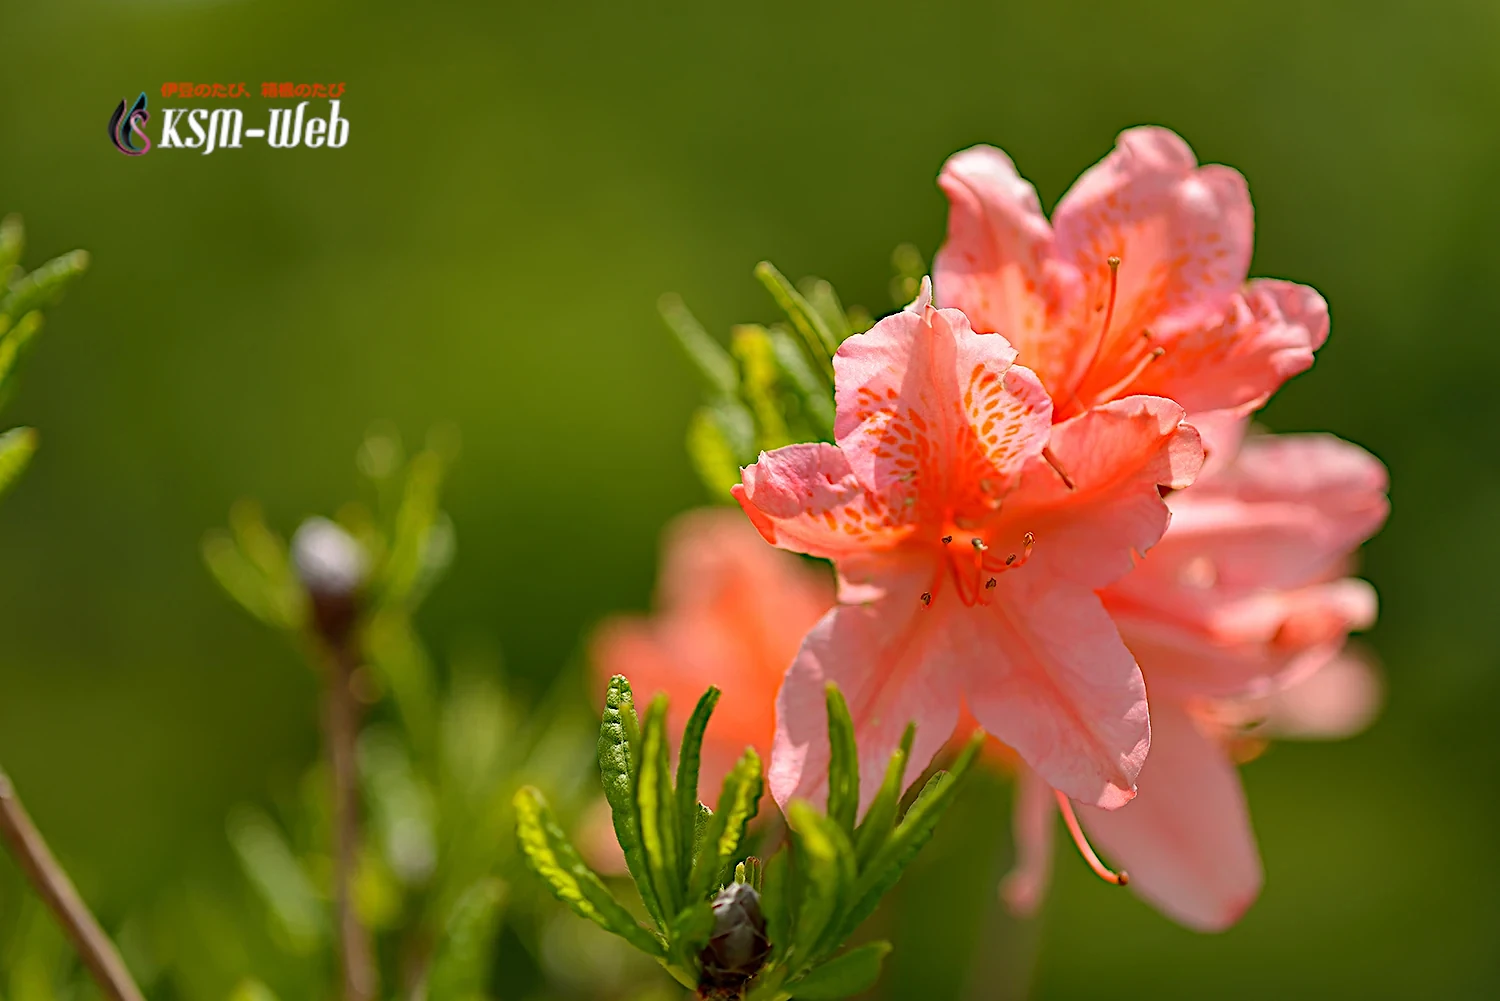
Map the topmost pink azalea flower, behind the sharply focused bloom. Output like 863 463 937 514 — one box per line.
933 128 1328 419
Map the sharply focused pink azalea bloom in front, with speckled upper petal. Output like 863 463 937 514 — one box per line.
735 282 1202 807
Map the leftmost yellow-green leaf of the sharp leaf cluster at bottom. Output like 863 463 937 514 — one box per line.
513 786 665 956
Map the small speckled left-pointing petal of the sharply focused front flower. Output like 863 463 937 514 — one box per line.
734 441 912 560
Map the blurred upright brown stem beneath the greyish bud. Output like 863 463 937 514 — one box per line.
324 636 375 1001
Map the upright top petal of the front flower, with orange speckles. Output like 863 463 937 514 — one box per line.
834 282 1052 518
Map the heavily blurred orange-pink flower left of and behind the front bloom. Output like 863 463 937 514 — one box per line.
591 509 834 798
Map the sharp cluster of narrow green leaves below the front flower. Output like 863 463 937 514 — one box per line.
516 675 983 1001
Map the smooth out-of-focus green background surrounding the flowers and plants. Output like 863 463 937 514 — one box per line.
0 0 1500 999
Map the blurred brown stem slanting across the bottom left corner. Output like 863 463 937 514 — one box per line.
0 770 144 1001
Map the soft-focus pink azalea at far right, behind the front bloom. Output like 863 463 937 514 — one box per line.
1005 425 1388 930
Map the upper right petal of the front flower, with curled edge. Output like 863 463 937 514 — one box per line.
1001 396 1203 588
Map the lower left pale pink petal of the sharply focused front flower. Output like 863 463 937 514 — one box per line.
767 561 968 810
